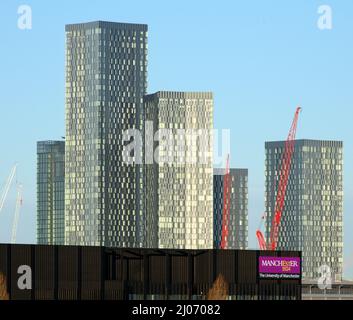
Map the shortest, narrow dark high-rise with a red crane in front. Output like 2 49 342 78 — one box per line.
213 168 248 249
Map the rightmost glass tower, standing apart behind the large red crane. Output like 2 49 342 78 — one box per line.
265 140 343 281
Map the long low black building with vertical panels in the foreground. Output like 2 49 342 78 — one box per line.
0 245 301 300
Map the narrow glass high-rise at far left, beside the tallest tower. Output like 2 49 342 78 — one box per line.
37 141 65 245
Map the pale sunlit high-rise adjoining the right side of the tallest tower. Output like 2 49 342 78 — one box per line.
145 91 213 249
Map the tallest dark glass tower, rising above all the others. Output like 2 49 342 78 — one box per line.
65 21 147 247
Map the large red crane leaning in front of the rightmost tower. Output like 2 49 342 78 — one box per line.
256 107 301 250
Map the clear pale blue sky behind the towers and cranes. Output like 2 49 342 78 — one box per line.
0 0 353 278
